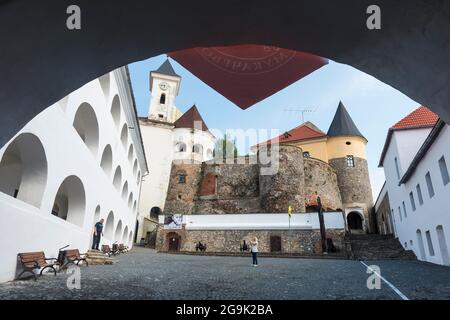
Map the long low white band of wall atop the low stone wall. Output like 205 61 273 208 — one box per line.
159 212 345 230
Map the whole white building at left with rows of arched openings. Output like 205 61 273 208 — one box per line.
0 67 147 282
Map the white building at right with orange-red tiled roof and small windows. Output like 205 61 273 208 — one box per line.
380 107 450 265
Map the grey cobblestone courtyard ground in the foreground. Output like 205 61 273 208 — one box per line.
0 248 450 300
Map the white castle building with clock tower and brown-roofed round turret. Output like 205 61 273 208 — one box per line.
137 60 216 240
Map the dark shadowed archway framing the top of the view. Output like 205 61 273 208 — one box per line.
0 0 450 146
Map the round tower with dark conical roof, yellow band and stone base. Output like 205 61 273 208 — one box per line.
327 102 373 232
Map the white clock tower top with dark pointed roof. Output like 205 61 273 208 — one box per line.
148 60 181 123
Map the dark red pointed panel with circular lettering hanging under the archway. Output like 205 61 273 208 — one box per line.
169 45 328 109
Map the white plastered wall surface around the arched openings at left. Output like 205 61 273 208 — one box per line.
0 70 145 282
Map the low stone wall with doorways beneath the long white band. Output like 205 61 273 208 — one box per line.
157 229 344 255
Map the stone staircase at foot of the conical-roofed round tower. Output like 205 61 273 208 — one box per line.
345 234 417 260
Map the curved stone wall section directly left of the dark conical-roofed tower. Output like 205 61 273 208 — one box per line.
303 158 342 211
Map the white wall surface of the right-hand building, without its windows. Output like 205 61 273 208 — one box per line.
385 126 450 264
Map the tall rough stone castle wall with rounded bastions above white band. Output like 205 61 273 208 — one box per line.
164 145 373 221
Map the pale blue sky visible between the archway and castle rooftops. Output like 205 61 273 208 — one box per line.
129 55 419 201
